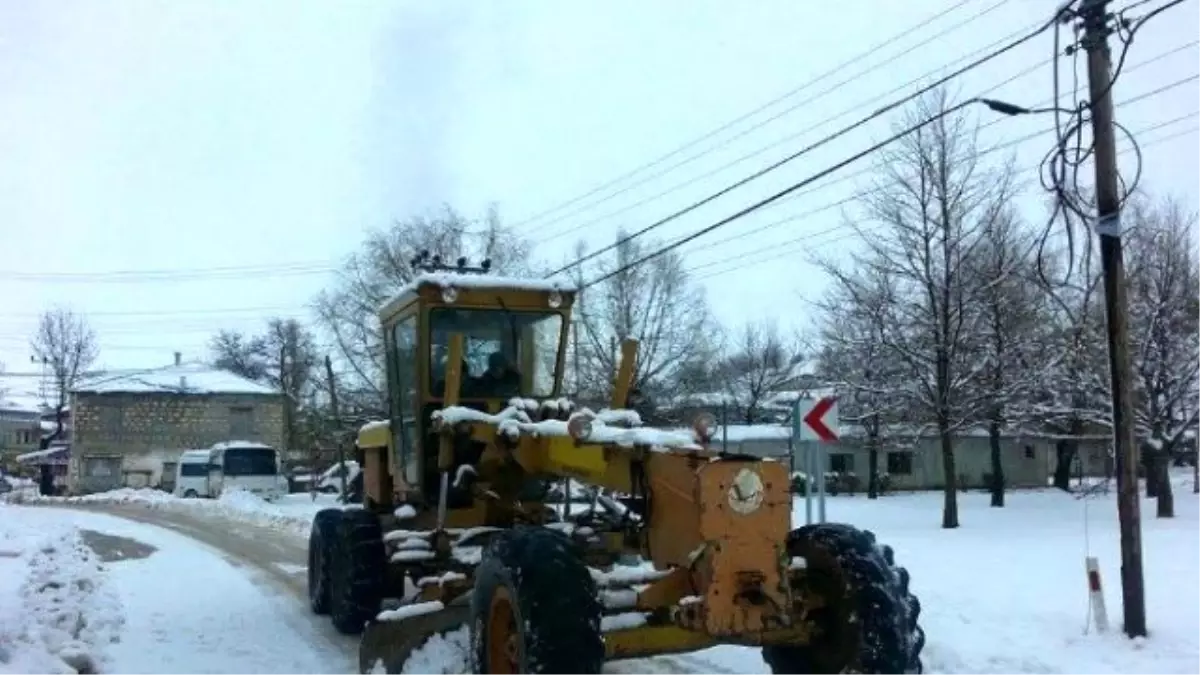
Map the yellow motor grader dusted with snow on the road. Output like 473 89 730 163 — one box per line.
308 256 924 675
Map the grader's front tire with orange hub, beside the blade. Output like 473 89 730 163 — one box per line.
470 526 605 675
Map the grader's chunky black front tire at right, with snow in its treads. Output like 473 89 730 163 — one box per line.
762 524 925 675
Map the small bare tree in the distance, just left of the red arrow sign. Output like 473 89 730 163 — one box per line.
719 319 804 424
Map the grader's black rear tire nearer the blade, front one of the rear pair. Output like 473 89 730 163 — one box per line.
329 509 388 635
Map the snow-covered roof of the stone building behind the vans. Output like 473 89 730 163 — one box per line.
73 363 278 394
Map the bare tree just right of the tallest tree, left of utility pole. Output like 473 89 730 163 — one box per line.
971 211 1052 507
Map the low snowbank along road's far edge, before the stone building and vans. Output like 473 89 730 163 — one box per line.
25 488 336 537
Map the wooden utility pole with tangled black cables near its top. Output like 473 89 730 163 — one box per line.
1079 0 1146 638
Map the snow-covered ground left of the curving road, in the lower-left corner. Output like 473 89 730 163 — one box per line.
0 506 354 675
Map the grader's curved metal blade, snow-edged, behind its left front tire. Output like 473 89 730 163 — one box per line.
359 604 470 675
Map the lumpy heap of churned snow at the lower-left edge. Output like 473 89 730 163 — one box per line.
0 507 125 675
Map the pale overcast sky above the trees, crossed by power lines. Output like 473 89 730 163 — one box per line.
0 0 1200 381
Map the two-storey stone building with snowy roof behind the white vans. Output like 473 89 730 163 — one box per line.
68 357 284 494
